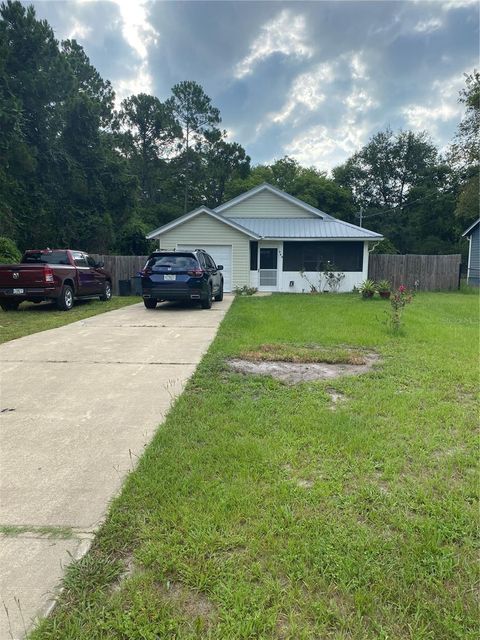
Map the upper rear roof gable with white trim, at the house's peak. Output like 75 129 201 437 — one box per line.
215 183 330 219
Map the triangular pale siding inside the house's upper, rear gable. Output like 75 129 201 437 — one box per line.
222 191 318 219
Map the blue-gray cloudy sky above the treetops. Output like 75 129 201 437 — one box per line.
25 0 479 169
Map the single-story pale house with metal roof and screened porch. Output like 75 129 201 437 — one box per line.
147 184 383 293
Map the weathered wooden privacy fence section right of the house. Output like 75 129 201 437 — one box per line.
368 254 462 291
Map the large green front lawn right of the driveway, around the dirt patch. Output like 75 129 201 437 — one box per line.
31 293 479 640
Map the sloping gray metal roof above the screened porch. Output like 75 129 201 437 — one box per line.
230 216 383 240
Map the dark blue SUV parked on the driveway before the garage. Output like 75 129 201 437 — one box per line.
141 249 223 309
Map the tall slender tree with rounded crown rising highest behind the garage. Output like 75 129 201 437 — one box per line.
167 80 221 212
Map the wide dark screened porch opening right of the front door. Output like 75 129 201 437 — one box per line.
283 241 363 271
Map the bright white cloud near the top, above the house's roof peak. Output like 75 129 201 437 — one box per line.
235 9 313 78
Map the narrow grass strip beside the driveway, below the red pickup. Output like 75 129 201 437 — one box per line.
0 296 142 344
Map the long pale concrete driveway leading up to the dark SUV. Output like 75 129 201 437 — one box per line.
0 296 233 640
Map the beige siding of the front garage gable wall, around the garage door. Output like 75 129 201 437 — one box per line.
159 213 250 287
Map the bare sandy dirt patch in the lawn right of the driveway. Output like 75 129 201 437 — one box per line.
227 353 379 382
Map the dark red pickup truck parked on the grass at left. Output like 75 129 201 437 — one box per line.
0 249 112 311
